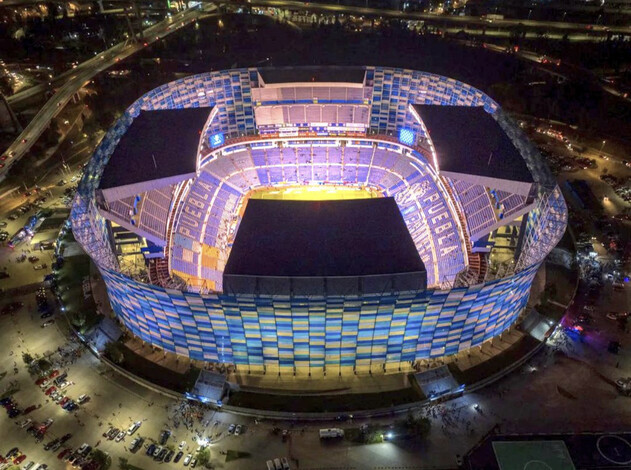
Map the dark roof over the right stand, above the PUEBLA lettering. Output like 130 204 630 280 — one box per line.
414 105 534 183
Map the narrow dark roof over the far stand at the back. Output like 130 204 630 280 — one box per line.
258 67 366 84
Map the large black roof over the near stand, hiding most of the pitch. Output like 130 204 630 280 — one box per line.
224 198 425 294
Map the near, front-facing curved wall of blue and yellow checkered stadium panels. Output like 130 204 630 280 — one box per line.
103 265 538 369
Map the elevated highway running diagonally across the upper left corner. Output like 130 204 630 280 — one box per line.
0 6 215 181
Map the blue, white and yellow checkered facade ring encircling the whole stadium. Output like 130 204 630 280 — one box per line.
71 67 567 372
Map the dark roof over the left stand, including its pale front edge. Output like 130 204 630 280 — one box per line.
99 108 211 200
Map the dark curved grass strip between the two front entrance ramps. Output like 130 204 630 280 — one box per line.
228 387 425 413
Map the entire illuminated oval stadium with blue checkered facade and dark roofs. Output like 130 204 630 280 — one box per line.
71 66 567 375
